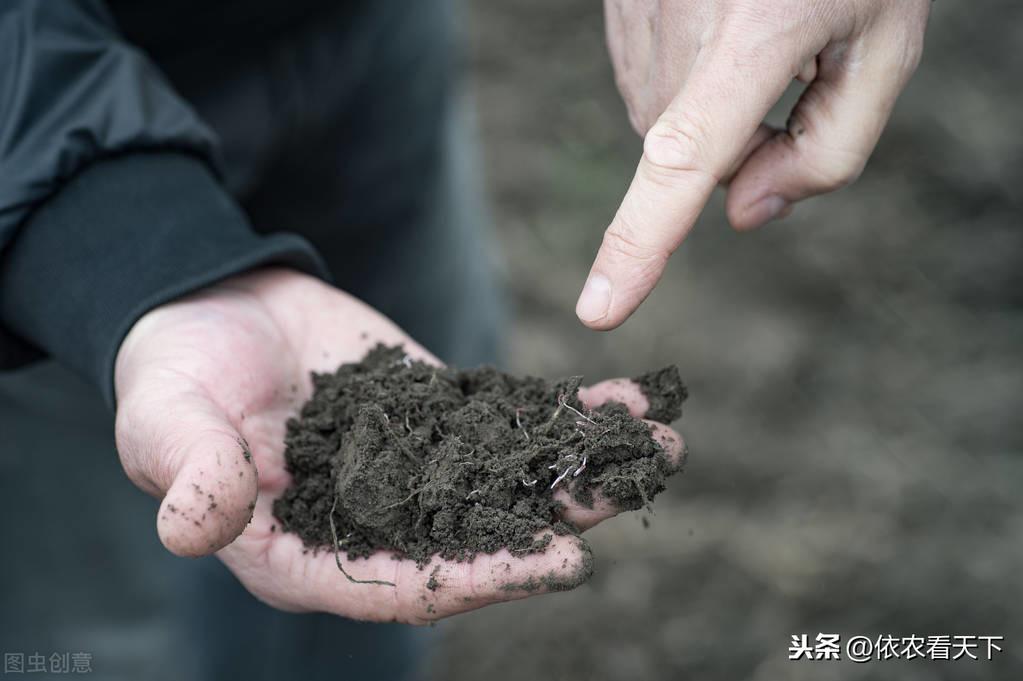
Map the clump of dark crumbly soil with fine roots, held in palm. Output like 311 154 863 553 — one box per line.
273 345 686 564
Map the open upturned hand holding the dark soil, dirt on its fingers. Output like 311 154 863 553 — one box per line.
115 270 682 623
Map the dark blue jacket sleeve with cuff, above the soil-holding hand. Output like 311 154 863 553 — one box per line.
0 0 325 404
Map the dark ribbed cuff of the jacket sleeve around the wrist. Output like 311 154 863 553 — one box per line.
0 152 326 406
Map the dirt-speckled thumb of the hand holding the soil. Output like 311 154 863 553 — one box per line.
116 385 258 556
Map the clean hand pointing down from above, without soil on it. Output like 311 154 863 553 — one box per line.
576 0 931 329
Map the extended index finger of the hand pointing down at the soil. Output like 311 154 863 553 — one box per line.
576 31 801 330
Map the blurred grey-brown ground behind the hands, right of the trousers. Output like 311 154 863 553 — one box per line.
434 0 1023 681
